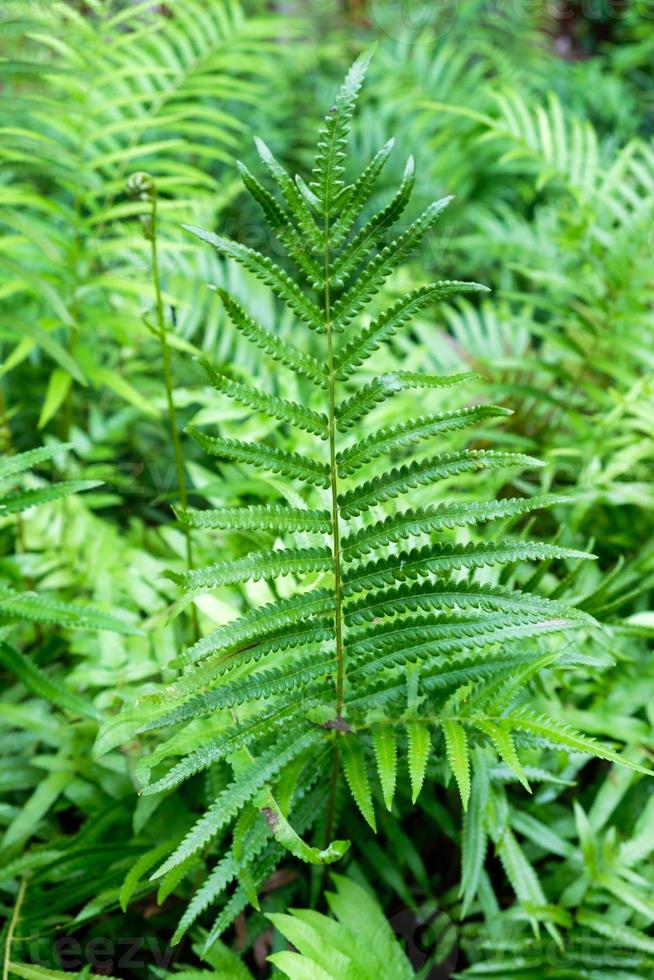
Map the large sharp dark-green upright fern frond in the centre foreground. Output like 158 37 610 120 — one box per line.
111 56 644 942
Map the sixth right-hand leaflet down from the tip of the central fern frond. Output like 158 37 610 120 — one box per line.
336 405 512 476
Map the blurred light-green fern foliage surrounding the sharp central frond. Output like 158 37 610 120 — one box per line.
0 0 654 980
